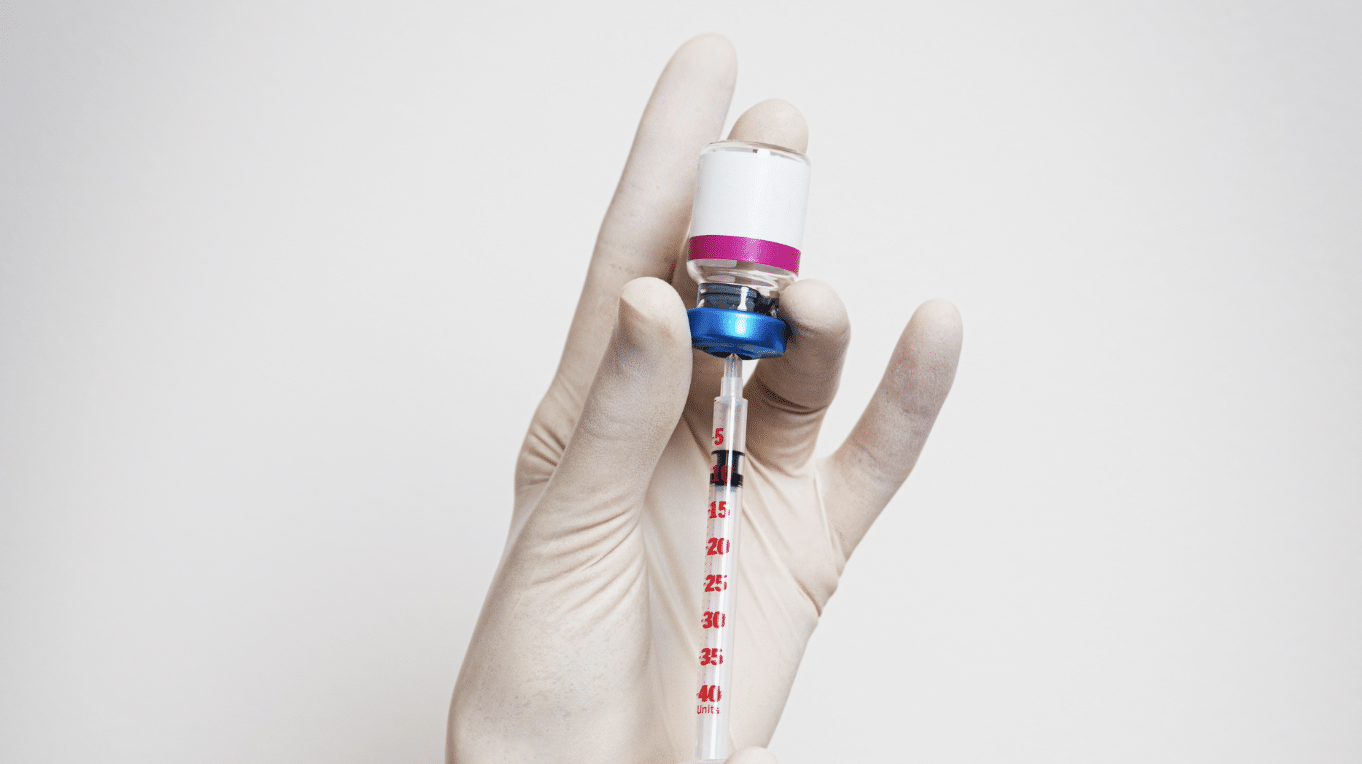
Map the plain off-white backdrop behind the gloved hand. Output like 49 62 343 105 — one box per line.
0 0 1362 764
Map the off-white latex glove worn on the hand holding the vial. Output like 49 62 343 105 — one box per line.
448 35 960 764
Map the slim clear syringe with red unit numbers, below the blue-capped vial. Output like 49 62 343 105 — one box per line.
696 375 748 761
